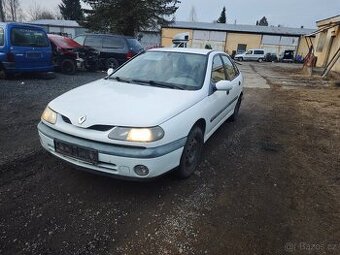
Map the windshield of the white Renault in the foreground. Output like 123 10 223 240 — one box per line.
110 51 207 90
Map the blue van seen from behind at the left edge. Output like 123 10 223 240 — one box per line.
0 22 53 76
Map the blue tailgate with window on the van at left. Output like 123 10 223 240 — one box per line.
10 26 52 71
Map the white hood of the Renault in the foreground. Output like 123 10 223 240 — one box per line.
49 79 205 128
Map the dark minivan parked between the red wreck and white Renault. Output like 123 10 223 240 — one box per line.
74 34 144 69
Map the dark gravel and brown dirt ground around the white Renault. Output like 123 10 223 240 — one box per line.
0 62 340 255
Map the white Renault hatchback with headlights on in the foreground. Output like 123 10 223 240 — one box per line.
38 48 243 179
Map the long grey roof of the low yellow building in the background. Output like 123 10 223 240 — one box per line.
163 21 314 36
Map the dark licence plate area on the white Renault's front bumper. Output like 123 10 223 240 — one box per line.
54 139 98 164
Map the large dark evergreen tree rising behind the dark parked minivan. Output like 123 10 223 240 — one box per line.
81 0 180 36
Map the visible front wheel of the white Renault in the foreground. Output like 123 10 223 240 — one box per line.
177 126 204 179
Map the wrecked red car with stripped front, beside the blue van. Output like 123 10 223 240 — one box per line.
48 34 98 74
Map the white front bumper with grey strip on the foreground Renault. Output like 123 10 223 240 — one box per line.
38 122 186 178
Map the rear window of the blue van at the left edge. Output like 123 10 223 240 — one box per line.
11 28 49 47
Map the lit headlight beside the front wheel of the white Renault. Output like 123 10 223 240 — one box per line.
109 127 164 142
